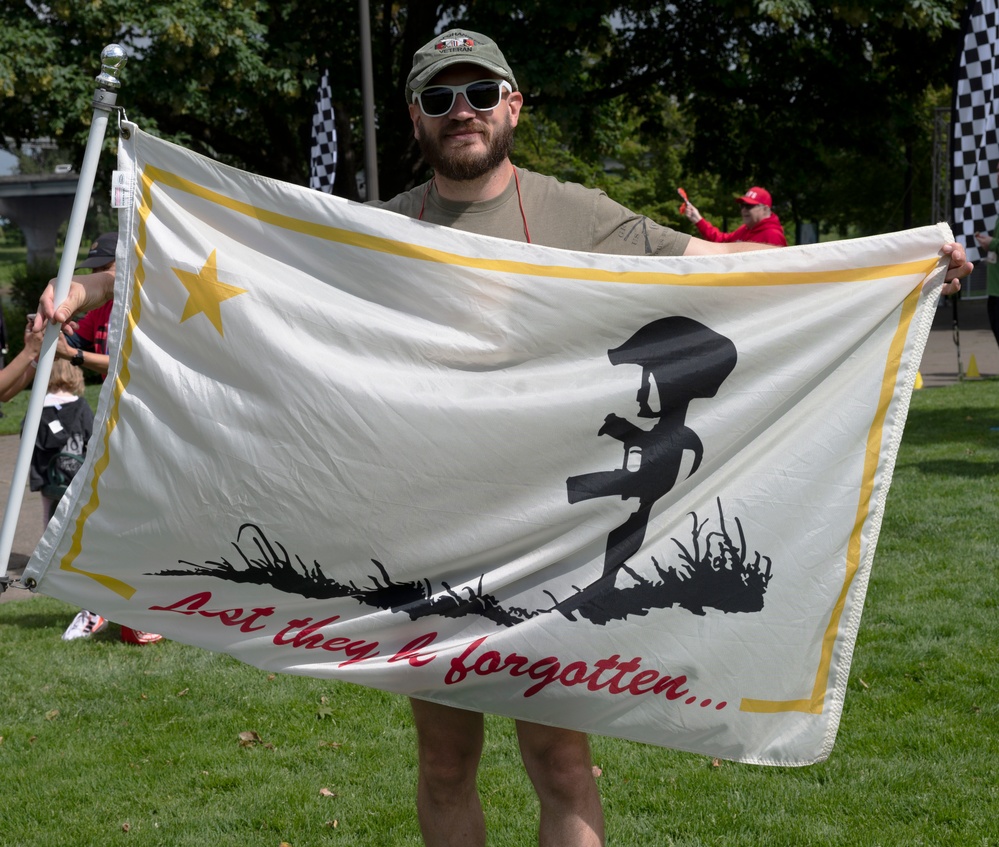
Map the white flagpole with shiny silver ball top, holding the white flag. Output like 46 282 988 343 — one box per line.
0 44 125 593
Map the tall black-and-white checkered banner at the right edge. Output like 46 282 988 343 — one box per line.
952 0 999 260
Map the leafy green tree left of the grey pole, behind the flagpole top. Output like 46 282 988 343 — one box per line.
0 0 360 193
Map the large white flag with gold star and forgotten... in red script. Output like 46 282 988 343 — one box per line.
25 126 950 765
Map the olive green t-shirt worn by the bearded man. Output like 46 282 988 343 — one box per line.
377 168 690 256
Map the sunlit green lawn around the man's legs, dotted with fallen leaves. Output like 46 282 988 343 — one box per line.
0 381 999 847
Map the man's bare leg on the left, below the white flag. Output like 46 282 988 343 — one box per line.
410 699 486 847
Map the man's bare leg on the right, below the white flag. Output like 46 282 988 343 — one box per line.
517 721 604 847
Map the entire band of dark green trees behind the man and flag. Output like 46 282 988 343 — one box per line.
0 0 965 237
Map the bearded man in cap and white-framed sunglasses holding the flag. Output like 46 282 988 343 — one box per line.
37 30 971 847
